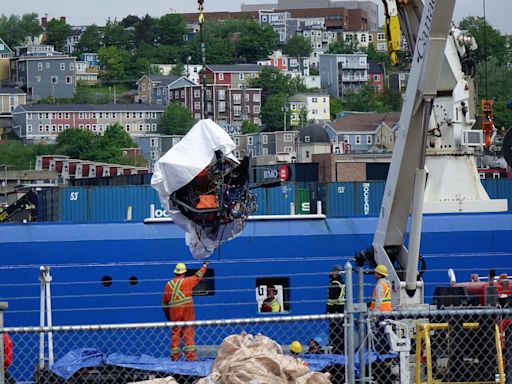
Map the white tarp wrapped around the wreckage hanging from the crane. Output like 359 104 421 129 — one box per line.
151 120 244 259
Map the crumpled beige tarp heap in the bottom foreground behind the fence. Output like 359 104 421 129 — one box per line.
197 334 331 384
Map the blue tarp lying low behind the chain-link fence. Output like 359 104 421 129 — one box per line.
50 348 397 380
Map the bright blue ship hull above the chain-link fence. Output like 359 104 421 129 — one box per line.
0 213 512 326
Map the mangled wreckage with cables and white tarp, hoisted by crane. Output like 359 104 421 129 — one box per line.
151 120 256 259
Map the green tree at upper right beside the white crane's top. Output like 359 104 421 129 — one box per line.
459 16 507 63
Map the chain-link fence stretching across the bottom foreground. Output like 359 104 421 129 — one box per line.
0 308 512 384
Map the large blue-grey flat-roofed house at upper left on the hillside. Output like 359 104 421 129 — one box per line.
11 56 76 101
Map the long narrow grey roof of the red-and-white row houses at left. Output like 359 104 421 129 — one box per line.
16 104 165 112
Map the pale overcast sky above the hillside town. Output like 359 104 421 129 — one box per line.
0 0 512 33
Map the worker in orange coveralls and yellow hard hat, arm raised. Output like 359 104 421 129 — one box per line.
162 261 208 361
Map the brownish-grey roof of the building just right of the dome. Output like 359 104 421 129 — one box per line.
329 112 400 132
